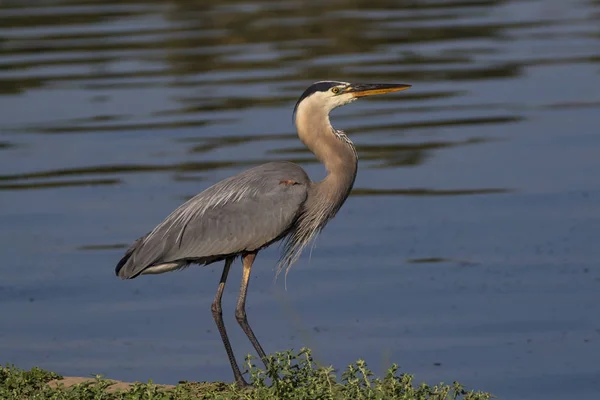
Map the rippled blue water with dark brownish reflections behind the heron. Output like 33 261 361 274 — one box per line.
0 0 600 400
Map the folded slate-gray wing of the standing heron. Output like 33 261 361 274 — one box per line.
116 162 310 279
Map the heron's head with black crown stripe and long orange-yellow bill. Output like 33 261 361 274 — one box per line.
294 81 411 119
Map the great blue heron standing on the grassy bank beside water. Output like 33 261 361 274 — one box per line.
116 81 410 386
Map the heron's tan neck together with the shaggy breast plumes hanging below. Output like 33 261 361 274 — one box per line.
278 98 358 274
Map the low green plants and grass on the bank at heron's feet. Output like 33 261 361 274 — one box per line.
0 349 493 400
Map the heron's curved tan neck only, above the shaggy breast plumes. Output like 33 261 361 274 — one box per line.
296 104 358 208
